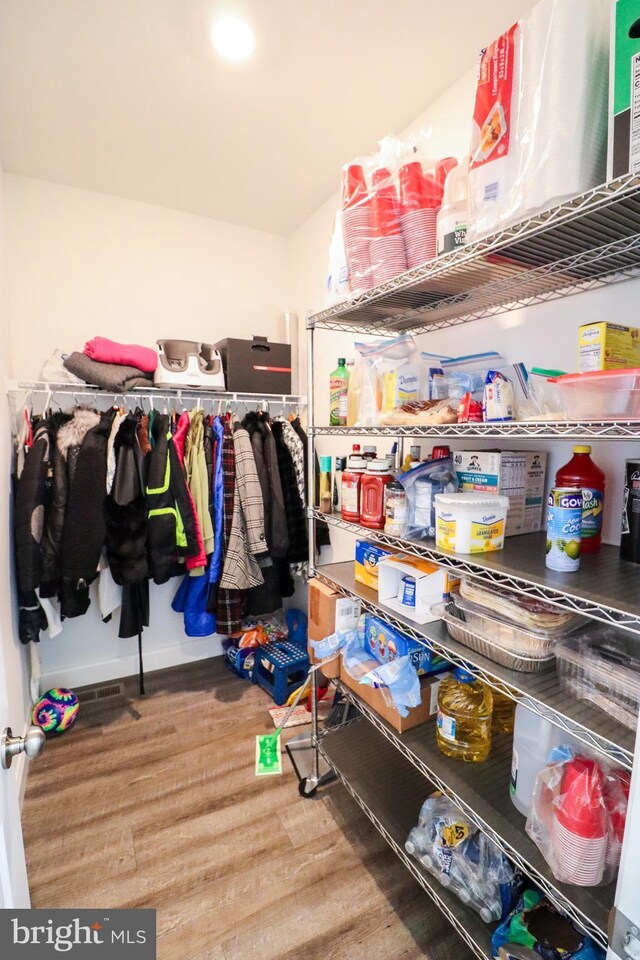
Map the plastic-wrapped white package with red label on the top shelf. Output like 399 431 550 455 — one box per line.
467 0 609 240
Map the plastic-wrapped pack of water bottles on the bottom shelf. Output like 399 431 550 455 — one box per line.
405 792 521 923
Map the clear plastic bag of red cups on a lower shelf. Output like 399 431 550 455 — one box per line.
527 747 629 887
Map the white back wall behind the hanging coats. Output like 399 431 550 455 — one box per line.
0 176 289 689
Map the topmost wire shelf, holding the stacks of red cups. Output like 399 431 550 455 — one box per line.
308 176 640 335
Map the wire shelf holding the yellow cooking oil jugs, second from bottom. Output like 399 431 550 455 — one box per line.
330 708 615 949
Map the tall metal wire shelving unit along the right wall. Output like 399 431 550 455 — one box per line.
301 175 640 958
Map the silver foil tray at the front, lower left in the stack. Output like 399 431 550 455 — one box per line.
433 594 556 673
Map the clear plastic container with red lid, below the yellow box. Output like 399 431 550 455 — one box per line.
558 368 640 420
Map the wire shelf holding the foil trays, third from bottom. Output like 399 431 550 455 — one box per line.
315 562 635 770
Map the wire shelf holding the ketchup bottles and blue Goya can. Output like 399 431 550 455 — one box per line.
309 509 640 633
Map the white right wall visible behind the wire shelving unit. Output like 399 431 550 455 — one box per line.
289 71 640 560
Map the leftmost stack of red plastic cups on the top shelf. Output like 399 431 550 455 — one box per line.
342 163 374 293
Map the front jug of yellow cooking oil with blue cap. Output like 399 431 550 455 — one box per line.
436 667 493 763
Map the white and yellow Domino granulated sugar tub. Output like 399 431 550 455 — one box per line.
435 493 509 553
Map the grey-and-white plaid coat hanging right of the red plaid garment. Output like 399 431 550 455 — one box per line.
220 418 268 590
